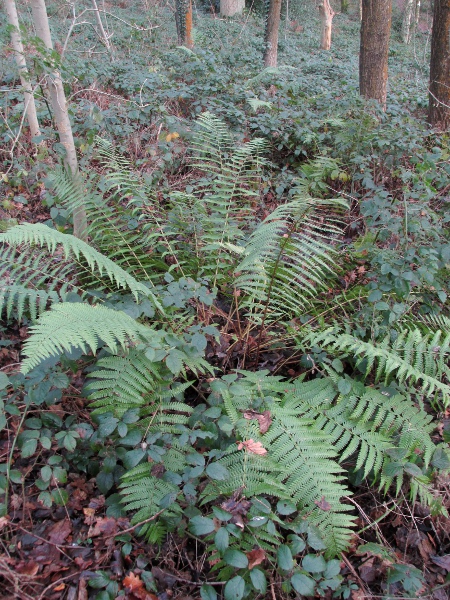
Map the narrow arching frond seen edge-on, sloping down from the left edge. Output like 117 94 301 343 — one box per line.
0 223 162 312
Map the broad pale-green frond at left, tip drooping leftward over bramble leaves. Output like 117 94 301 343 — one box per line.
22 302 154 373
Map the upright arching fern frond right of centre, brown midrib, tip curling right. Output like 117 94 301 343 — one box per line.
235 199 342 320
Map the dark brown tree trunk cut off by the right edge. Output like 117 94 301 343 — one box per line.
428 0 450 131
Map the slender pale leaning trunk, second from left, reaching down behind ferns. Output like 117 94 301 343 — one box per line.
31 0 87 239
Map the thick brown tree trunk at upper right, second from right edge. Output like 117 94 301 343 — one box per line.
359 0 392 108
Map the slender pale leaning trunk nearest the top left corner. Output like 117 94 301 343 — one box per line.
5 0 41 138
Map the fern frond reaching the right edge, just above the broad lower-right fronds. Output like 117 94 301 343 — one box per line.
302 327 450 405
